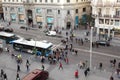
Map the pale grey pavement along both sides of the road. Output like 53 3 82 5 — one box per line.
0 23 120 80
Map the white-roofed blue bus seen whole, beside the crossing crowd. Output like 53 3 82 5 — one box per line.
12 39 53 56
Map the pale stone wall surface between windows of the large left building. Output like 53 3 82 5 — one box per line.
2 0 90 28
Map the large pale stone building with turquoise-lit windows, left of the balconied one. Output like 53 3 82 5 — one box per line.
2 0 91 29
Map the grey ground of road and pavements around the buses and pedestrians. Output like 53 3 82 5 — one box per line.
0 21 120 80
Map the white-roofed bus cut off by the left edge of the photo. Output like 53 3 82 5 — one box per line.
0 31 19 44
